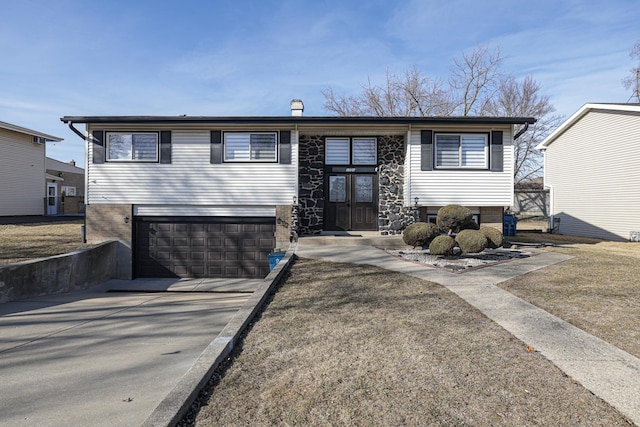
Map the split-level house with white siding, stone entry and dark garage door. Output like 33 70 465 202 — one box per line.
61 100 535 277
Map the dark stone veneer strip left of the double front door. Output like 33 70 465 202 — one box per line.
298 135 324 234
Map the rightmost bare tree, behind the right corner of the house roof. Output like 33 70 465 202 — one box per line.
485 76 562 182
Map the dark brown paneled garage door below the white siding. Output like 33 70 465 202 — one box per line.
135 218 275 278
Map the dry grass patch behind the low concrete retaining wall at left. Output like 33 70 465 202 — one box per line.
0 221 86 265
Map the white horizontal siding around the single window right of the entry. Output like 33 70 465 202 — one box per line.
405 126 513 207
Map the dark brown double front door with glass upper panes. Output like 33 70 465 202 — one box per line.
324 172 378 231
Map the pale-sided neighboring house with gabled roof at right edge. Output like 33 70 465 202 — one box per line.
537 104 640 240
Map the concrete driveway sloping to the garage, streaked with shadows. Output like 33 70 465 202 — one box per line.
0 280 262 427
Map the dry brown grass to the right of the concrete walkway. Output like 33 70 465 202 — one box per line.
499 234 640 357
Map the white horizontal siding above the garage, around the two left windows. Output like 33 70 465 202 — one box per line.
87 130 298 207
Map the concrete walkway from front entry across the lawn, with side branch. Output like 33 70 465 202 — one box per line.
295 238 640 425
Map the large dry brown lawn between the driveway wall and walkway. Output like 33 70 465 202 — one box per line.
181 259 628 426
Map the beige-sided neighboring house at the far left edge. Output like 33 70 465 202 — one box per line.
0 122 62 216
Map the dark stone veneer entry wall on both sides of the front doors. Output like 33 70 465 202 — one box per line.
298 135 416 235
